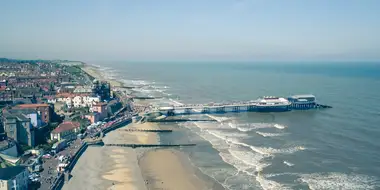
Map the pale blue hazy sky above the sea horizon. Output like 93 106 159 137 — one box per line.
0 0 380 60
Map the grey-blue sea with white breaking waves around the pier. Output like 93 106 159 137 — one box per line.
90 61 380 190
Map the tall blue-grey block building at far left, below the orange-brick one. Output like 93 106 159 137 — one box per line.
3 111 35 147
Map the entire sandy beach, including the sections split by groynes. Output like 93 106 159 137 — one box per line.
62 64 224 190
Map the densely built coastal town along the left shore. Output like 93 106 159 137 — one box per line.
0 58 140 189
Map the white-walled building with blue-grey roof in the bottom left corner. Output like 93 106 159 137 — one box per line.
0 166 29 190
